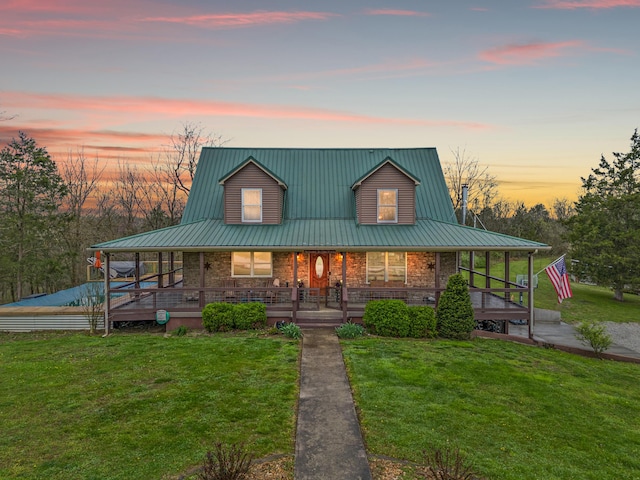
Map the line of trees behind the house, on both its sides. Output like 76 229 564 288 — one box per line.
0 123 640 303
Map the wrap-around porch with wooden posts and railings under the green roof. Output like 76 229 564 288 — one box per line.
105 250 533 333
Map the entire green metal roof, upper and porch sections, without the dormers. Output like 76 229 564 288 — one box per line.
91 147 549 252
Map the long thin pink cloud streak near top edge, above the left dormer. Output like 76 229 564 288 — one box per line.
142 11 337 28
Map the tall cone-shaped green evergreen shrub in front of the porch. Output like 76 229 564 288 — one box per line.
436 273 476 340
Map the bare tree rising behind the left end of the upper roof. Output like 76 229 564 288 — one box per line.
165 122 229 193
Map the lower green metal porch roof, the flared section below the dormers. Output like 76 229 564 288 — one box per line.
89 219 551 252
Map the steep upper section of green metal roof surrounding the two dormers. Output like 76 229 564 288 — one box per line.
182 147 456 223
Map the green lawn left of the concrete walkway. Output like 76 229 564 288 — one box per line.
0 333 299 480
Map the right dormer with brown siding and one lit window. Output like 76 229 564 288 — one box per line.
351 157 420 225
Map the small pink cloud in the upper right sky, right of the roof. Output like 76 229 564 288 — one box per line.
478 40 584 65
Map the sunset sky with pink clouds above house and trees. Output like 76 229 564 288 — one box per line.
0 0 640 205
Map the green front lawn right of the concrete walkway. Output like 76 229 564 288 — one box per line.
343 339 640 480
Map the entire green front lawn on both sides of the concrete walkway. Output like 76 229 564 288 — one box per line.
0 333 640 480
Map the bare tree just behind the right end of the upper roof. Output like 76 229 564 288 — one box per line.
444 147 498 222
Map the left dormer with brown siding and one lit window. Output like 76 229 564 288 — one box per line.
218 157 287 225
